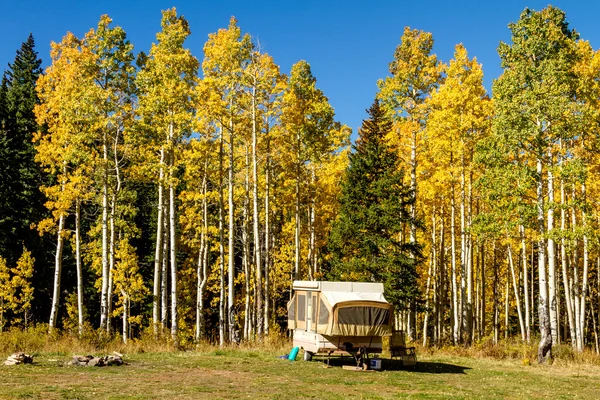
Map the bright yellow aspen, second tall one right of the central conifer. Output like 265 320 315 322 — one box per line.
427 45 492 343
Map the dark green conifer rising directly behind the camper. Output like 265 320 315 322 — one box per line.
329 100 419 306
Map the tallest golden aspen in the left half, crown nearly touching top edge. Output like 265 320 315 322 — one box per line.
137 8 198 346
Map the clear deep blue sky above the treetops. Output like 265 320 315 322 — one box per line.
0 0 600 135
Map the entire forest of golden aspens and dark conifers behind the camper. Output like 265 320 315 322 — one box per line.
0 6 600 361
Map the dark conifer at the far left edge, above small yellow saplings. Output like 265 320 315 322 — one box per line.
0 34 45 264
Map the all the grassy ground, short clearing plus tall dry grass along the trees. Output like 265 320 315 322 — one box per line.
0 328 600 399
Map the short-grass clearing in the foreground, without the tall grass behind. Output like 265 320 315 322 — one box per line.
0 350 600 400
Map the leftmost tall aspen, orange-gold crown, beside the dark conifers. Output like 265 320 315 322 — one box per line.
34 33 99 330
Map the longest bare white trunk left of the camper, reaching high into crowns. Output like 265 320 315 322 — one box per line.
252 83 265 340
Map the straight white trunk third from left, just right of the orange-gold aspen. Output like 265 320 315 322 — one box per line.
100 132 109 329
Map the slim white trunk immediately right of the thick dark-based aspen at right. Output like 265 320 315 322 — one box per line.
547 153 559 343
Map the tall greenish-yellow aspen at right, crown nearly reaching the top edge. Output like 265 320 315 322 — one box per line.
493 6 577 362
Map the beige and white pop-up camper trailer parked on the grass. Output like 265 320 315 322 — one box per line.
288 281 394 359
